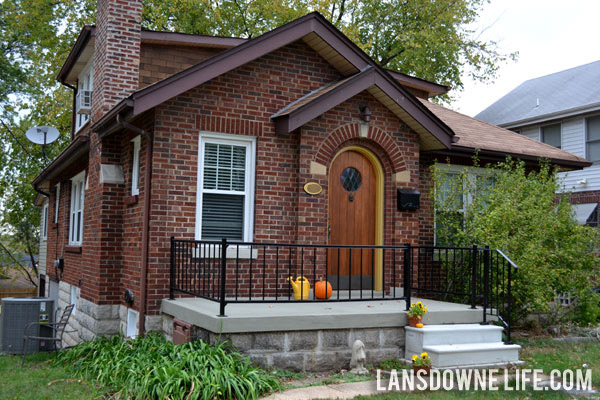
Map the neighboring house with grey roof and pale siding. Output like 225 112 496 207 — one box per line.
476 61 600 226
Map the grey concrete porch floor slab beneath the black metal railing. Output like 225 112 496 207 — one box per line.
161 298 491 333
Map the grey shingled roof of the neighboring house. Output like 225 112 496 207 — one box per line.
476 61 600 127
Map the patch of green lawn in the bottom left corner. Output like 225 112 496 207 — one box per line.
0 353 104 400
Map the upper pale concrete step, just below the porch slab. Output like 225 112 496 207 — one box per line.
405 324 503 352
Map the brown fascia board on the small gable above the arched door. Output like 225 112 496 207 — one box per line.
272 67 454 148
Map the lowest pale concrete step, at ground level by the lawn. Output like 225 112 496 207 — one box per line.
414 343 521 368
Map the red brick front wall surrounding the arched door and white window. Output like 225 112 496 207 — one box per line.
148 42 428 313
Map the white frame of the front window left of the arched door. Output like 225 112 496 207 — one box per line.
196 131 256 242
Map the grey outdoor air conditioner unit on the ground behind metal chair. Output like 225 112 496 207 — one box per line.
0 297 54 354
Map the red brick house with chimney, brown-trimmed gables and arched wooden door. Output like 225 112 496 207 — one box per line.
33 0 589 354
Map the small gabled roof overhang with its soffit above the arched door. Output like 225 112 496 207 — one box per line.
271 67 454 150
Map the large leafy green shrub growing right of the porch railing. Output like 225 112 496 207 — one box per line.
432 159 600 324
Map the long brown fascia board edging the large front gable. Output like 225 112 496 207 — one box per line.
132 13 373 115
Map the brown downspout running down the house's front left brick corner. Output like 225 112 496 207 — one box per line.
117 115 154 336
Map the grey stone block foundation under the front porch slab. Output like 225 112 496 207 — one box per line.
177 322 404 372
